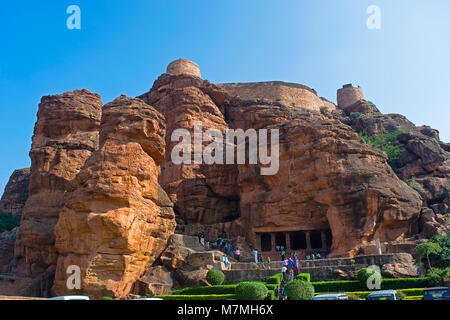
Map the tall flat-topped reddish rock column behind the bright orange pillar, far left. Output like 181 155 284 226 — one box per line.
15 90 102 277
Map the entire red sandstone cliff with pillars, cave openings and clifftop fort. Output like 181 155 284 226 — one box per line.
0 59 450 298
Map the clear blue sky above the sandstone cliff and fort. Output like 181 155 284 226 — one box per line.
0 0 450 193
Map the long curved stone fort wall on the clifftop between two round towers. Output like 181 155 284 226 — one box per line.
219 81 336 111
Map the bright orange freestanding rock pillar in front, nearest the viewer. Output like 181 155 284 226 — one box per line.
54 96 175 298
